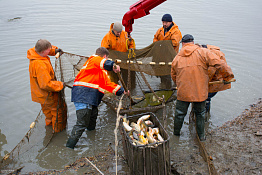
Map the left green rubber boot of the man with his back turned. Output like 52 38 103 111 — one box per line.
174 100 190 136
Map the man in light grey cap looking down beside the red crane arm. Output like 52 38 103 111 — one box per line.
101 22 136 85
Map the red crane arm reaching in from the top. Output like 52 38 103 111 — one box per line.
122 0 166 36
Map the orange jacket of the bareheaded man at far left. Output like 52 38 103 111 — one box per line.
27 46 63 104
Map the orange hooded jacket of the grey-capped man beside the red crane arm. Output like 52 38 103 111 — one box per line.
101 23 134 52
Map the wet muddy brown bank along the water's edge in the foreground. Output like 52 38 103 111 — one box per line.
7 99 262 175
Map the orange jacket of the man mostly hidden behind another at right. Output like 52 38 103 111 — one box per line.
207 45 231 93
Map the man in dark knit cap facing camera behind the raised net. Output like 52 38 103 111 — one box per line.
153 14 182 53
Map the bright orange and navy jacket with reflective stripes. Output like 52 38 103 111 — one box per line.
71 55 124 106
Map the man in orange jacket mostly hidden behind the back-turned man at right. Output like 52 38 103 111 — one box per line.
198 44 231 112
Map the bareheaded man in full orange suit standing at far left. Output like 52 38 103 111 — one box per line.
27 39 67 132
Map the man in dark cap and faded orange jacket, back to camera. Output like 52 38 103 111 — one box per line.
171 34 234 141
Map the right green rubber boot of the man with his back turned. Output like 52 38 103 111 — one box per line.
194 102 206 141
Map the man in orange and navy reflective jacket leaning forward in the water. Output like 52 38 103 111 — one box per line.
66 47 128 149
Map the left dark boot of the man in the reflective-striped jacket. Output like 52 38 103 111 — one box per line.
66 108 92 149
